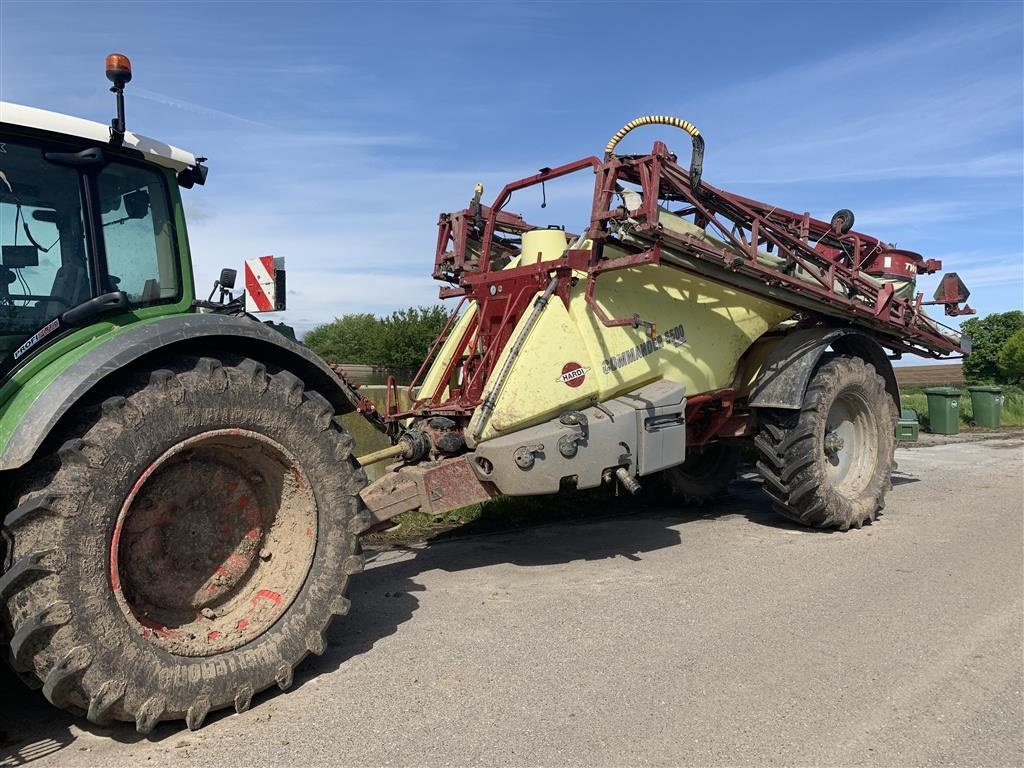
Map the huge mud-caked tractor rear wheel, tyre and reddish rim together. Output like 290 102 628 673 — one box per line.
0 354 366 733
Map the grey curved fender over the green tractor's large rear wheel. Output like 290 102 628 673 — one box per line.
0 314 352 471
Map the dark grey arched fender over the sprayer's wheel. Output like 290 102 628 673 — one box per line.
750 328 900 412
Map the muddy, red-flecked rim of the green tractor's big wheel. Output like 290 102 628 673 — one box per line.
110 429 316 656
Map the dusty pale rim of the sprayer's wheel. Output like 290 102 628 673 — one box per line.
822 393 878 495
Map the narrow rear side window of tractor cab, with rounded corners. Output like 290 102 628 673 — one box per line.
96 163 181 306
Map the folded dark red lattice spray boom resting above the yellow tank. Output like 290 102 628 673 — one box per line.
588 142 966 356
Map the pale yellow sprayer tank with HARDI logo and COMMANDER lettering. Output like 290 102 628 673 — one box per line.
464 240 793 442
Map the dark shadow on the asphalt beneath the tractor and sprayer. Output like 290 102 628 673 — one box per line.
0 474 860 757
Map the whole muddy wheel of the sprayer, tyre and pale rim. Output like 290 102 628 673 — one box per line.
755 357 896 530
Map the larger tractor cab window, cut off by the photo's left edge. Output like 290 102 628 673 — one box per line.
0 140 93 360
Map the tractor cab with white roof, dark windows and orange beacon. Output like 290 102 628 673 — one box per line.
0 57 206 379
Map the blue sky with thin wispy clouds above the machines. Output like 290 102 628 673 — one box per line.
0 0 1024 342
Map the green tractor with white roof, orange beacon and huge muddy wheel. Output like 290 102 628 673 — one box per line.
0 54 366 733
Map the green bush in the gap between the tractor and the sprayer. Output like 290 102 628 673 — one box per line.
302 305 449 369
